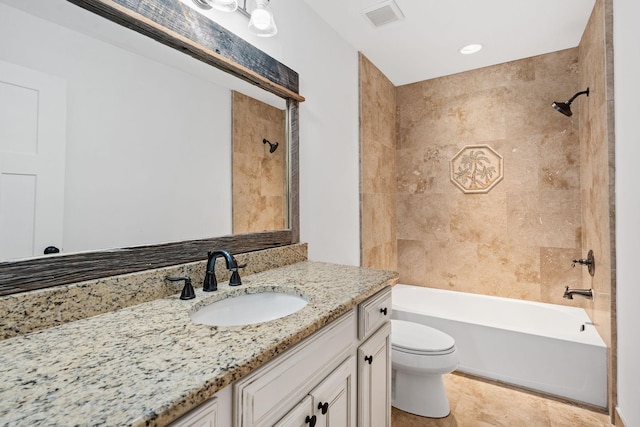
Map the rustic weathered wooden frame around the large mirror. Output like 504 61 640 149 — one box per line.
0 0 304 295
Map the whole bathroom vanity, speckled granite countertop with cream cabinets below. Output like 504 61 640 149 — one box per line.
0 261 397 427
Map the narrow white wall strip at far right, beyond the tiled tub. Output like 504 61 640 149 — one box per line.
613 0 640 427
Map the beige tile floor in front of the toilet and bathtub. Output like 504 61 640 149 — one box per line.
391 374 611 427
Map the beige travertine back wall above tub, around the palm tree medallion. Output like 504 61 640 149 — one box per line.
396 48 585 306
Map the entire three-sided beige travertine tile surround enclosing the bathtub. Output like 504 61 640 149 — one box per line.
360 0 616 410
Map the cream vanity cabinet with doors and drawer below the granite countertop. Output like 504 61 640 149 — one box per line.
176 288 391 427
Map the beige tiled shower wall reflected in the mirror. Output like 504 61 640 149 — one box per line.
233 91 287 233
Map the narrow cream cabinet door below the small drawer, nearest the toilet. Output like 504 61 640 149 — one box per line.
358 322 391 427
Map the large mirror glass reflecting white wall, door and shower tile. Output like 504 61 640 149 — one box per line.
0 0 297 293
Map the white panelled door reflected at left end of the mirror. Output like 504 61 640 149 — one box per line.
0 61 67 260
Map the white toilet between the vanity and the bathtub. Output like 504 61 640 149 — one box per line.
391 319 459 418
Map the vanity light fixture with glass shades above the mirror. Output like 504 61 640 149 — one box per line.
193 0 278 37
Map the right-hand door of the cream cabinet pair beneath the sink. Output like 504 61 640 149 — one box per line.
310 356 356 427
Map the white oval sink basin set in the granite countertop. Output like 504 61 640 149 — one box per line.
191 292 307 326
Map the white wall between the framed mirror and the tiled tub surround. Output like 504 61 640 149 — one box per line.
204 0 360 265
